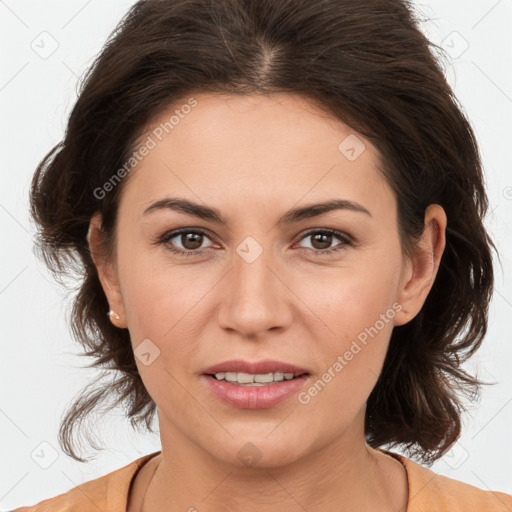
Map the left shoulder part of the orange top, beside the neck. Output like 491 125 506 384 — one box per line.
11 452 160 512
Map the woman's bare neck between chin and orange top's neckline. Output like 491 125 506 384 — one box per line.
144 408 408 512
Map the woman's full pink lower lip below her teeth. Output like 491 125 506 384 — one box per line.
202 374 310 409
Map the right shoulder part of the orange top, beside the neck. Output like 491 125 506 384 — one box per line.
383 450 512 512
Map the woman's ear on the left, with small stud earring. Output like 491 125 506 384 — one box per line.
87 213 127 328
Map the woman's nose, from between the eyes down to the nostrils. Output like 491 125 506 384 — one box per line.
217 242 293 339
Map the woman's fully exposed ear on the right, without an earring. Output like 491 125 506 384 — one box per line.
395 204 447 325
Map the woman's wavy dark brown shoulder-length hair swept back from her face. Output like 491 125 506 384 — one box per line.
30 0 496 463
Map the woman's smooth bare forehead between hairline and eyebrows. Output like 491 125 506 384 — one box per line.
119 93 393 218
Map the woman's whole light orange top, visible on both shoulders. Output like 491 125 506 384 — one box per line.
12 448 512 512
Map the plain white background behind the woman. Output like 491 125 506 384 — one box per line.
0 0 512 510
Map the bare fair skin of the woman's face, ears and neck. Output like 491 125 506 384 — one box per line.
90 93 446 512
